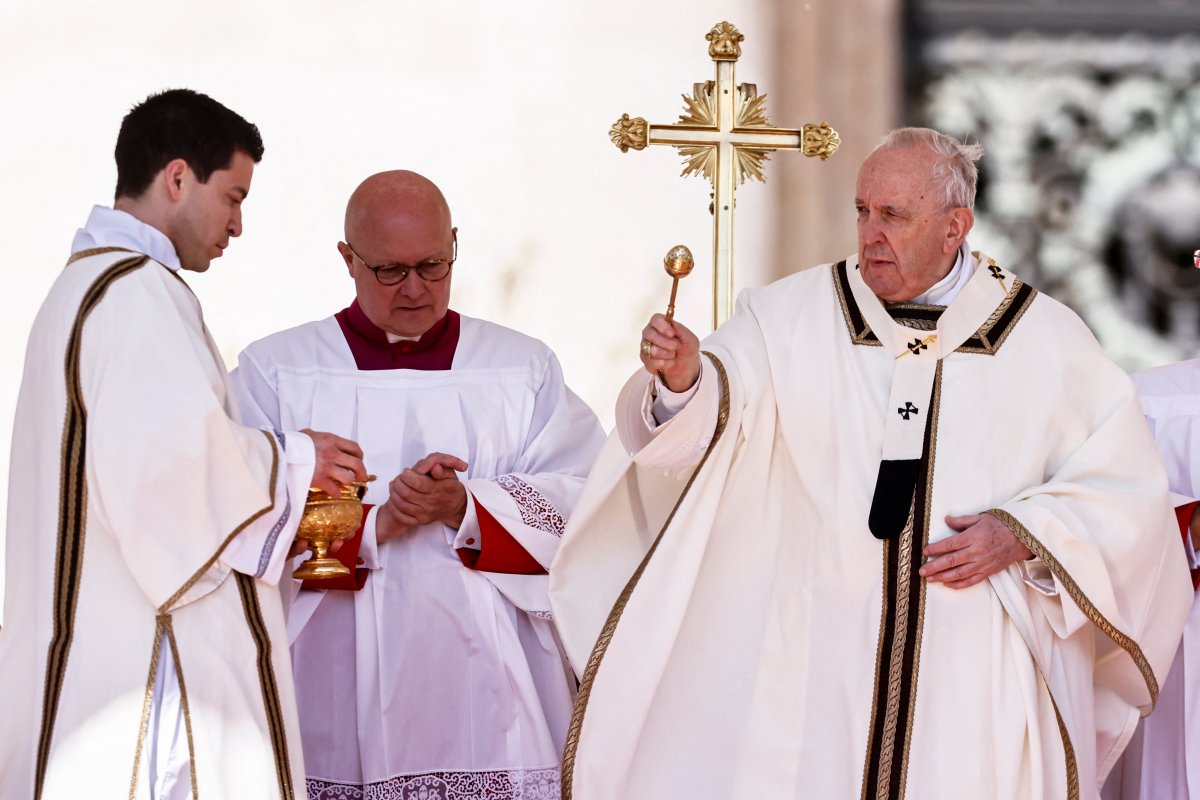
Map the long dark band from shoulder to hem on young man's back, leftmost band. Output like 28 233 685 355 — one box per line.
34 251 150 800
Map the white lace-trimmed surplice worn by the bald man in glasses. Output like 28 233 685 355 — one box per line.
234 317 604 800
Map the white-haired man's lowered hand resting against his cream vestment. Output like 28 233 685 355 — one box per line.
920 513 1033 589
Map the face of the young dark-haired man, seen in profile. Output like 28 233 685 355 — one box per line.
167 151 254 272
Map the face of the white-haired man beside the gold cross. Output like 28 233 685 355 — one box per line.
854 148 971 302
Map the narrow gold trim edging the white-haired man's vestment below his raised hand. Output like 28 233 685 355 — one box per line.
562 353 730 800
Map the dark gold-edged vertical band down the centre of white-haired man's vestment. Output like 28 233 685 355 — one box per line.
860 361 942 800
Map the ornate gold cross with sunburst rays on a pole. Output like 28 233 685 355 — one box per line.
608 22 841 329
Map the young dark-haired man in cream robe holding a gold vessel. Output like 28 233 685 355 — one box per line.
0 90 364 800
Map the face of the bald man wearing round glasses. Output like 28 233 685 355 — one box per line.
338 209 454 336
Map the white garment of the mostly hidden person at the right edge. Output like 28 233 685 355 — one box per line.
1104 359 1200 800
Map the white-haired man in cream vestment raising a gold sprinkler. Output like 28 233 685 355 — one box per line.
551 128 1190 800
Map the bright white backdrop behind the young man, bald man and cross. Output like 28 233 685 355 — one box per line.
0 0 787 522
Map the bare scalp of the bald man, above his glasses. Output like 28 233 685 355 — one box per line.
346 169 451 243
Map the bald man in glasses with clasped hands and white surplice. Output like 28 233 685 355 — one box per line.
235 170 604 800
